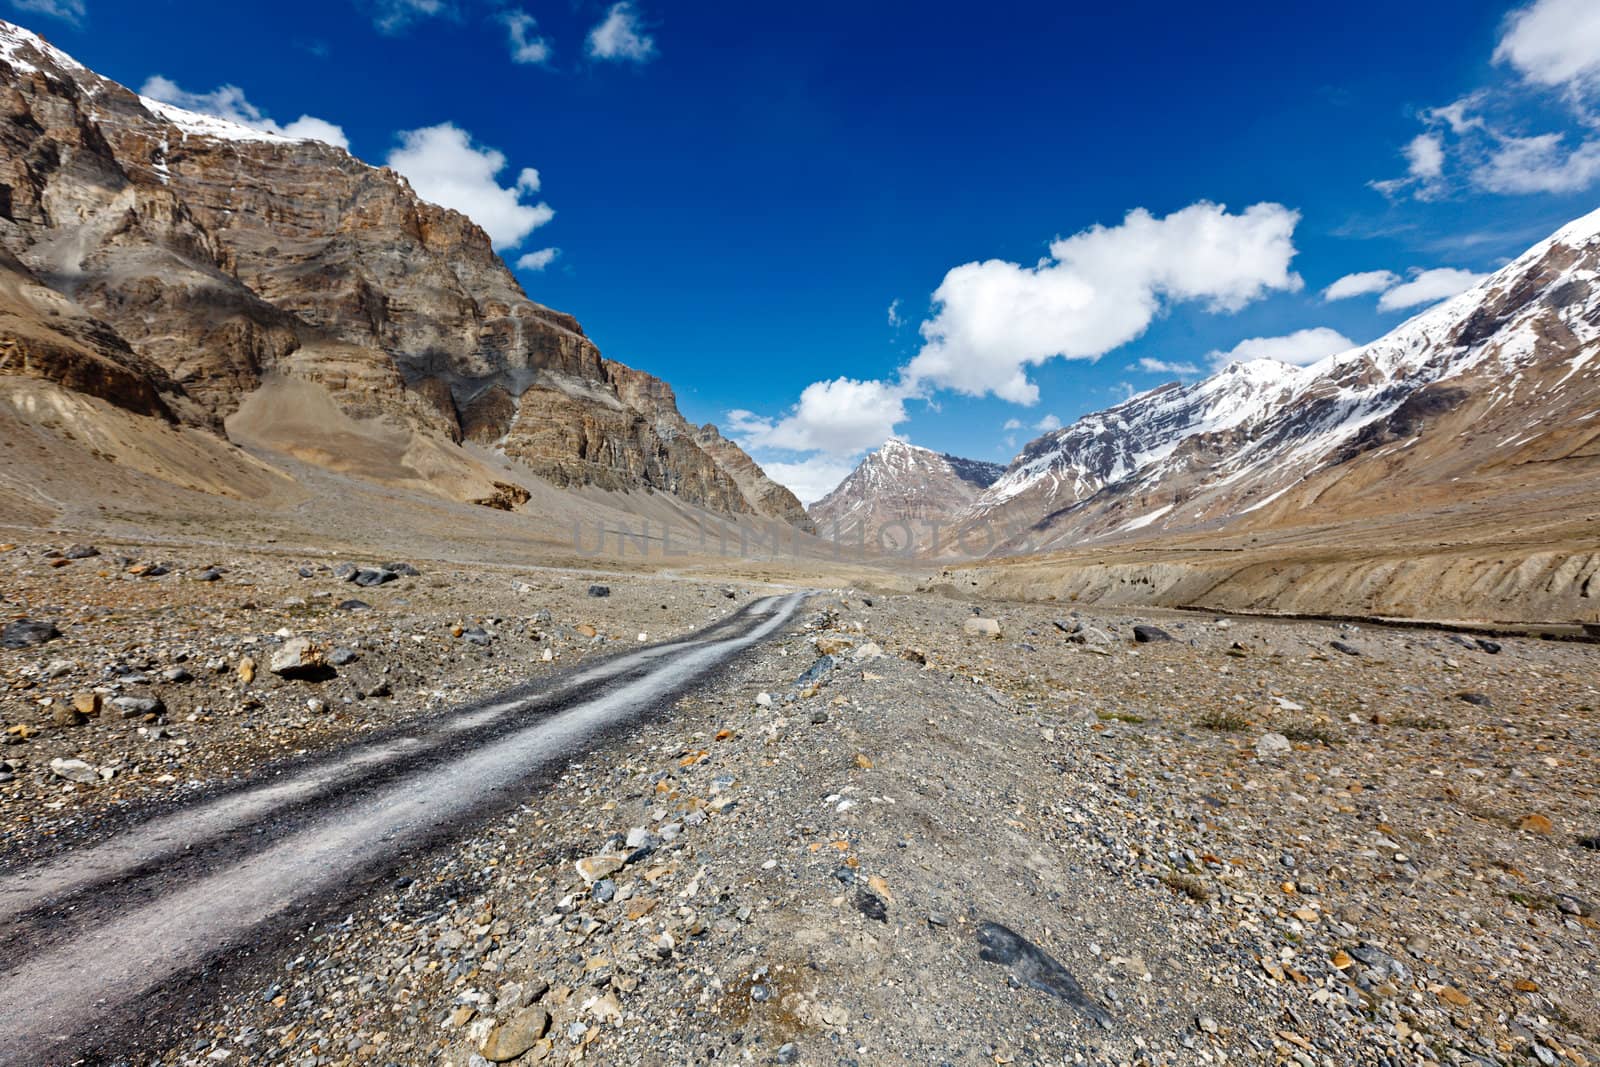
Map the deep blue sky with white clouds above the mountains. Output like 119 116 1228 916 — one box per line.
5 0 1600 496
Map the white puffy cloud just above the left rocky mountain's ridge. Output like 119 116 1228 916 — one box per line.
389 122 555 248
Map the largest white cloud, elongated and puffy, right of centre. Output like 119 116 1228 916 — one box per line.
904 202 1301 403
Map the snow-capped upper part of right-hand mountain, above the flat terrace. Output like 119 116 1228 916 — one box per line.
968 211 1600 550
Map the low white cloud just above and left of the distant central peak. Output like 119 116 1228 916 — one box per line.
728 378 909 456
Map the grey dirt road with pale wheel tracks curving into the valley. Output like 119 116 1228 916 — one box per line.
0 593 803 1064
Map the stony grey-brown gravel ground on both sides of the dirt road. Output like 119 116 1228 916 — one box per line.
0 545 1600 1067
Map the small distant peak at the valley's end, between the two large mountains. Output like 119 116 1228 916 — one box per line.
808 440 1003 552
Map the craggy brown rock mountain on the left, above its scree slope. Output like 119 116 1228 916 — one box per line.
0 22 805 522
